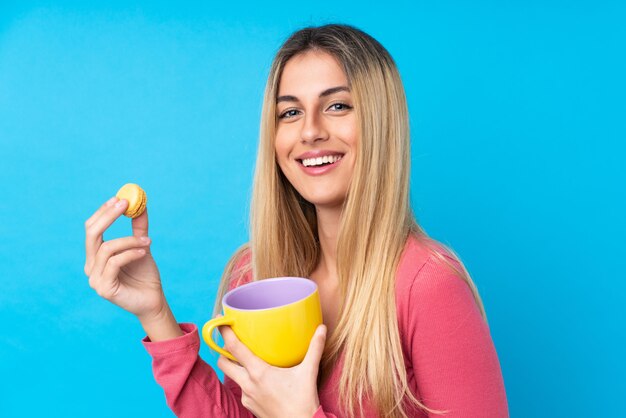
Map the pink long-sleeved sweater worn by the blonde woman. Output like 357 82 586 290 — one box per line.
143 237 508 418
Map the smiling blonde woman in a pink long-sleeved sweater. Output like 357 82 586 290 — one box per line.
85 25 508 418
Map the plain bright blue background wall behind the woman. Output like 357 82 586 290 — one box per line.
0 1 626 417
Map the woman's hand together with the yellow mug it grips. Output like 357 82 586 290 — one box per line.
202 277 326 418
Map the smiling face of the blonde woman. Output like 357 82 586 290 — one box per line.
275 51 359 208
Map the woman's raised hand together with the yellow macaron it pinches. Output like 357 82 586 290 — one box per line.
85 184 182 341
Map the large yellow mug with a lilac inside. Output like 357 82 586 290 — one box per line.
202 277 322 367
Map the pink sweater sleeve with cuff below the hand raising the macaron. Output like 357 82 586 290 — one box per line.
143 324 253 418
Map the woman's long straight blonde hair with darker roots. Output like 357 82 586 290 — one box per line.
216 24 484 417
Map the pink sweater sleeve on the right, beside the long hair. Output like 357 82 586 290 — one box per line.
409 257 508 418
